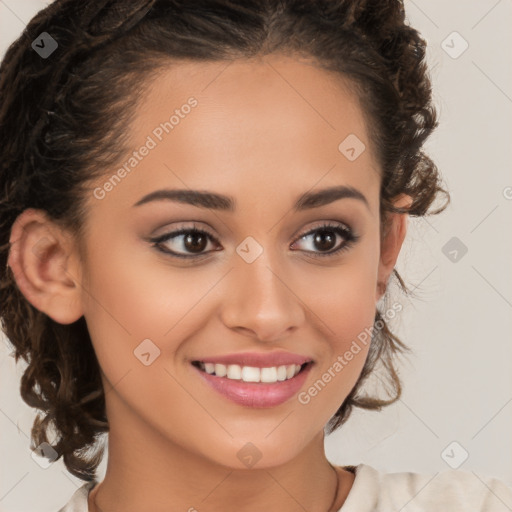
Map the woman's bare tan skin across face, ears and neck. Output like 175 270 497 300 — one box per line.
9 55 410 512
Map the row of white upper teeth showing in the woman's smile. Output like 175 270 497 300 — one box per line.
200 362 301 383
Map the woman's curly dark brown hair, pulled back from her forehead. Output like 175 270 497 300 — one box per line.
0 0 450 481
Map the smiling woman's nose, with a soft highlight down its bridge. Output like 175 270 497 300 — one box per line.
221 252 306 342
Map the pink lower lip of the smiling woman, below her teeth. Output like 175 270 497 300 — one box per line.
192 363 311 407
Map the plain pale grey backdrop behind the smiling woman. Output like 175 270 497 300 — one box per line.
0 0 512 512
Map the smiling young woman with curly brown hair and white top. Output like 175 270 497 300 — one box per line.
0 0 512 512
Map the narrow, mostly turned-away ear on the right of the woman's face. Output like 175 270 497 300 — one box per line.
375 194 412 301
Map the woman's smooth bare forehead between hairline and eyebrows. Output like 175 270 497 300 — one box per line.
88 55 379 213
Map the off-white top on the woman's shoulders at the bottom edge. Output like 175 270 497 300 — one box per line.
58 464 512 512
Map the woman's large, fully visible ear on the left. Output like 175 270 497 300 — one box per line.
7 208 83 324
